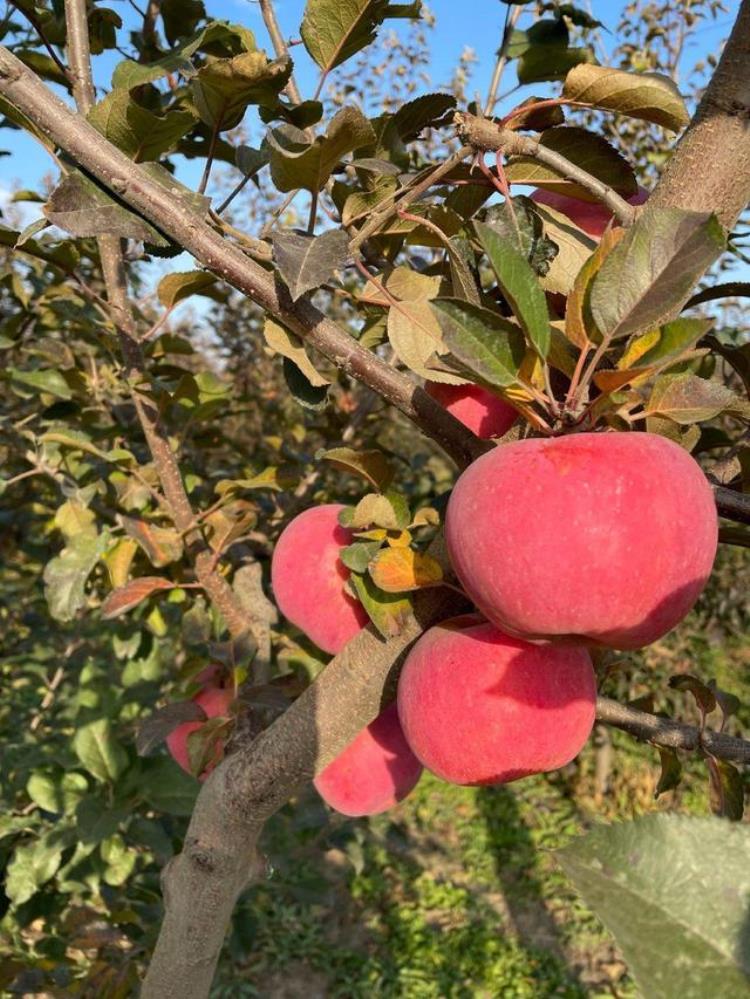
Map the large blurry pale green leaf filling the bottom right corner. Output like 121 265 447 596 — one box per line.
557 815 750 999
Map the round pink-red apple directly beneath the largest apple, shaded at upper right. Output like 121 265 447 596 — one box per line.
398 617 596 784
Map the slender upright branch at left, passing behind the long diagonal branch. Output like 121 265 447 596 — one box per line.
65 0 250 636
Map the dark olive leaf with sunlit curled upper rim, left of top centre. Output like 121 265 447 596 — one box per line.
190 52 292 132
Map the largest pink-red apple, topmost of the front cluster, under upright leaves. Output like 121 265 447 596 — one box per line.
445 433 718 649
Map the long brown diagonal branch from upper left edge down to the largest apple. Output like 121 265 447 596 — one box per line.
0 46 487 466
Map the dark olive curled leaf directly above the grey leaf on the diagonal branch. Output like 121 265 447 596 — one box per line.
266 107 375 192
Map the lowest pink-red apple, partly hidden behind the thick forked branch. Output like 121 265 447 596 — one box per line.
314 704 422 817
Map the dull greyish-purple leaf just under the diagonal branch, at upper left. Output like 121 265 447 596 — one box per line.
43 171 168 246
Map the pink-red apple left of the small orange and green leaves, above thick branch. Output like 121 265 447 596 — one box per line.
271 503 369 655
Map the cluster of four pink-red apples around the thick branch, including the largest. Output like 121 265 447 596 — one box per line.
271 426 718 816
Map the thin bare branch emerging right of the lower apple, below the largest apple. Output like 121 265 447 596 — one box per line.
596 697 750 763
